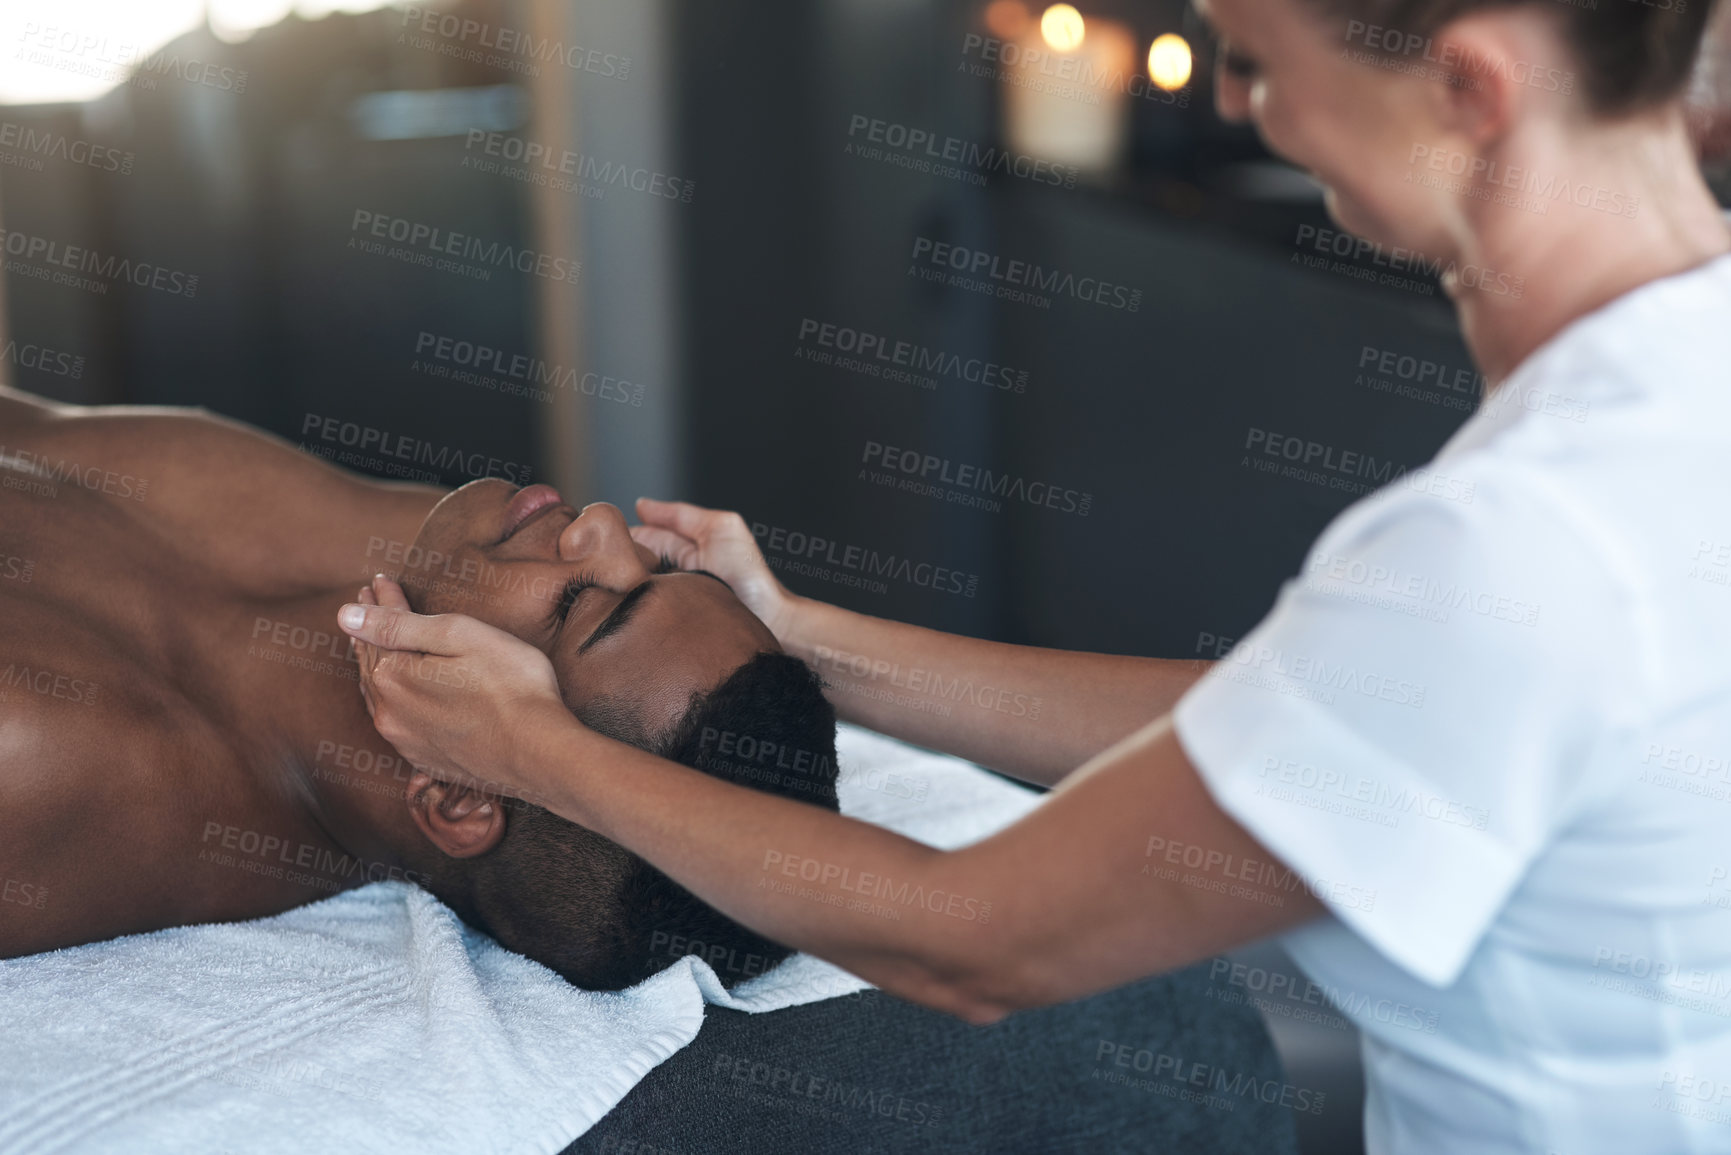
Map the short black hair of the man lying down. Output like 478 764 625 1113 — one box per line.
433 653 840 990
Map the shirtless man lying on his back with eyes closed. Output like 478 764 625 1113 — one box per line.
0 388 836 989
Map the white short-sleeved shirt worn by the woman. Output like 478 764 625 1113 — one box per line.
1174 245 1731 1155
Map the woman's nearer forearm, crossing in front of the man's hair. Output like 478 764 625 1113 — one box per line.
511 710 1014 1022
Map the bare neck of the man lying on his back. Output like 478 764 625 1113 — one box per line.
223 589 428 866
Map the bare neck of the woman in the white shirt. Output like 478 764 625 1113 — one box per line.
1447 106 1731 383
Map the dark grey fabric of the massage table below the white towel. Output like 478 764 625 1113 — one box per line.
564 966 1297 1155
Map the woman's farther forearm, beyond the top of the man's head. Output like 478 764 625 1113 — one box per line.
782 599 1210 786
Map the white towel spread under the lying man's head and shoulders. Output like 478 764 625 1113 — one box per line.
0 726 1037 1155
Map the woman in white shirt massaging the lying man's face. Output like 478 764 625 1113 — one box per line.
344 0 1731 1155
